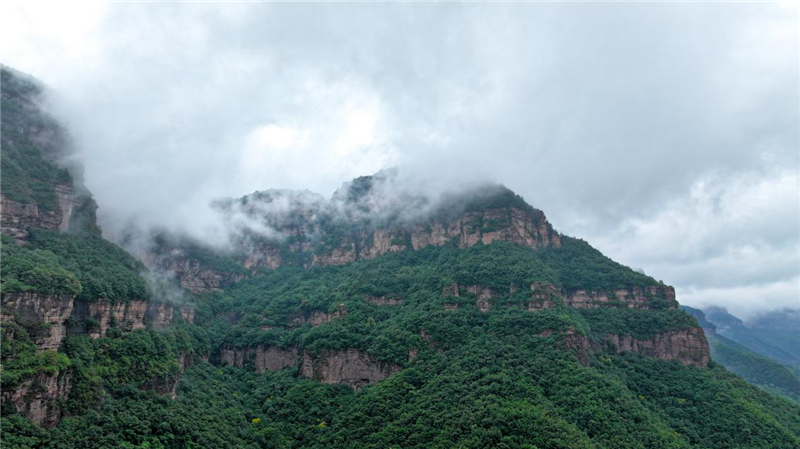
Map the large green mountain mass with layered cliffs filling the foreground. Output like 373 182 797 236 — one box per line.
0 69 800 448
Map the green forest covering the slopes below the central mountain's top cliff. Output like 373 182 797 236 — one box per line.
2 217 800 449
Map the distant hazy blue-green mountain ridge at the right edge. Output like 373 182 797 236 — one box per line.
681 306 800 403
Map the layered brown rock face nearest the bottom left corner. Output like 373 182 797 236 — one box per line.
0 370 72 427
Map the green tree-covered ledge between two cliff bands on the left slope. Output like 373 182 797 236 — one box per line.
18 230 150 300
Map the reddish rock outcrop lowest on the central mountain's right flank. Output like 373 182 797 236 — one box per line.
603 327 710 368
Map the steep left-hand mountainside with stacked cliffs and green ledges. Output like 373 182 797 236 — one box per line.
0 67 202 426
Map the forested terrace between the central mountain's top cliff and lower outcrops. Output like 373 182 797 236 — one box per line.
213 238 668 365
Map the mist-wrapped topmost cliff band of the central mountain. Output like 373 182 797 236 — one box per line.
150 175 561 294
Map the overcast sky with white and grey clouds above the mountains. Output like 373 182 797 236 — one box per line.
0 1 800 318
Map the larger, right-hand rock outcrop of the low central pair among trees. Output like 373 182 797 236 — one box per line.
300 349 400 390
